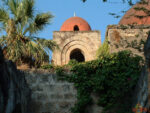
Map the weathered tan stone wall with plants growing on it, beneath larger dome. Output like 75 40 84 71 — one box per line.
106 25 150 58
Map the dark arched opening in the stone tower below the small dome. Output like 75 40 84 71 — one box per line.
70 49 85 62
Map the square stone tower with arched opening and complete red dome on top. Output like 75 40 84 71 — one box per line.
52 16 101 65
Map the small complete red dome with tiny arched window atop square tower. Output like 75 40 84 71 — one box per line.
60 17 91 31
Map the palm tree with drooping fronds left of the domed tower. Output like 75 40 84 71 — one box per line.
0 0 56 65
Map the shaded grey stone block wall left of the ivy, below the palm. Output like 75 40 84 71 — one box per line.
26 70 76 113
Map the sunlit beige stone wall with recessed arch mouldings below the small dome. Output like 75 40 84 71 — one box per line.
52 31 101 65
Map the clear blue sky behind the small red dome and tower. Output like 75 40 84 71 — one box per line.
35 0 130 42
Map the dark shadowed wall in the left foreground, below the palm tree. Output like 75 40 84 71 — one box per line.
0 48 30 113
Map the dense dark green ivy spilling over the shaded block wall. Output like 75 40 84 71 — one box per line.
56 51 142 113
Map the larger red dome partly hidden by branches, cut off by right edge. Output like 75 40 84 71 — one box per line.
119 0 150 25
